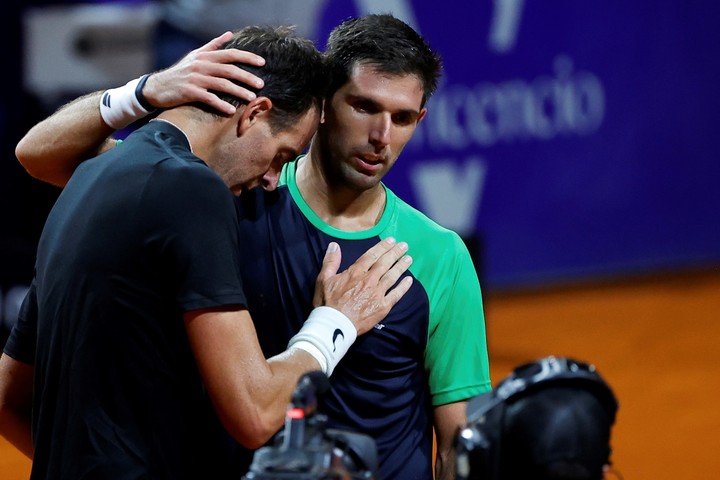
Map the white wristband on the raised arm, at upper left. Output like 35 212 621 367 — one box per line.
100 75 152 130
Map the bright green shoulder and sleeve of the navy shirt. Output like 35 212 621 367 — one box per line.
384 189 491 406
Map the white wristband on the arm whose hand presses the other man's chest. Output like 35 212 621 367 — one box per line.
288 307 357 377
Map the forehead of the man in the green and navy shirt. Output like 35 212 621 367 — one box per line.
339 63 424 110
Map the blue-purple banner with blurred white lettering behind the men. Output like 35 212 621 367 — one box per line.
318 0 720 287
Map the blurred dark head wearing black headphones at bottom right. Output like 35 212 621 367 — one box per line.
455 356 618 480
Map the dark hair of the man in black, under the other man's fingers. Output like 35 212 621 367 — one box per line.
205 26 328 132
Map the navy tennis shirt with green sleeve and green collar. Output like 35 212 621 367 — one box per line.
237 157 490 480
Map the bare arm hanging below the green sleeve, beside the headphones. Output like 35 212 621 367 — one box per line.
433 402 467 480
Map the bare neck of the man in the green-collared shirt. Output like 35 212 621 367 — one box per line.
295 148 385 232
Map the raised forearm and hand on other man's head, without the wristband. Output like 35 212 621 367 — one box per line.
15 32 264 186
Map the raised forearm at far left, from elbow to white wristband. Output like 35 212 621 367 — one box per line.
15 92 114 186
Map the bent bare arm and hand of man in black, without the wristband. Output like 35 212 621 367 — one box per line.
186 241 412 448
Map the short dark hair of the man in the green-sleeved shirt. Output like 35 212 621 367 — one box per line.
325 14 442 106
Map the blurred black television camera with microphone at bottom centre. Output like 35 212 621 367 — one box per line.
243 371 377 480
